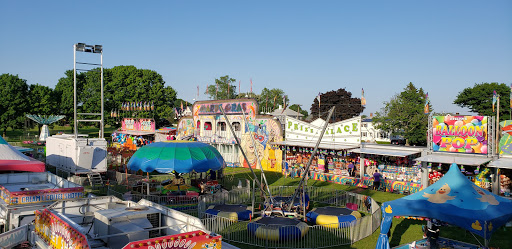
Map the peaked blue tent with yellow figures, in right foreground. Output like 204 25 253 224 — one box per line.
375 163 512 248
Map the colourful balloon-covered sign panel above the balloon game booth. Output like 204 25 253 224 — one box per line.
432 115 488 154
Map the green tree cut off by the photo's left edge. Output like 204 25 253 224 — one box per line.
0 74 29 137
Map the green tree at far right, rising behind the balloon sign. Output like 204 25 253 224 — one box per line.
453 82 510 120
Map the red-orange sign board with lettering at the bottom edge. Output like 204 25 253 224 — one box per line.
123 230 222 249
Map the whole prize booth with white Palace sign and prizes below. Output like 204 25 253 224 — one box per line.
272 116 361 180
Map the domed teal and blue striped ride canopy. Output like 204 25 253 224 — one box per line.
128 141 225 173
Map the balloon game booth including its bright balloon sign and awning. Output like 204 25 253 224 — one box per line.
415 115 498 193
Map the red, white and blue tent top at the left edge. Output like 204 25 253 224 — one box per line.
0 137 45 172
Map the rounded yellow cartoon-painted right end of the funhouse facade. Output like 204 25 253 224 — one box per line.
238 118 283 172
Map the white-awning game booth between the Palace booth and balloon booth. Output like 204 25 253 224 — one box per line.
349 143 427 194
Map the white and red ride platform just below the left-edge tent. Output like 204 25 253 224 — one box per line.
0 172 84 232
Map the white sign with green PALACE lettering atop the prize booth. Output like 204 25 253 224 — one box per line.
285 116 361 144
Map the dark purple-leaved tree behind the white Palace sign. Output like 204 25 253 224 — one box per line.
310 88 364 122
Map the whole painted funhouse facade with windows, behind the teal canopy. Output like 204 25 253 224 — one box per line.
177 99 283 172
